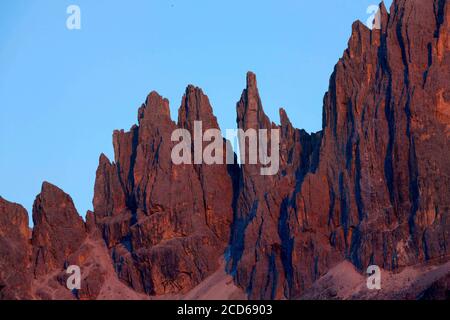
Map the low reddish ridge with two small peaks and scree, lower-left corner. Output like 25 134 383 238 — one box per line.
0 182 142 300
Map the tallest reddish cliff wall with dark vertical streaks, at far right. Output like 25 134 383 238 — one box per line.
291 0 450 294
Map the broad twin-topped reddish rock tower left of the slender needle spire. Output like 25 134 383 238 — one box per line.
94 86 237 295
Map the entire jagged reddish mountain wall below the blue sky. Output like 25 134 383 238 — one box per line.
0 0 450 299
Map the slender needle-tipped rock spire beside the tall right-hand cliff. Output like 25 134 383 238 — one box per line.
228 72 321 299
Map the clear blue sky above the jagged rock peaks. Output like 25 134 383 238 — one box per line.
0 0 391 216
